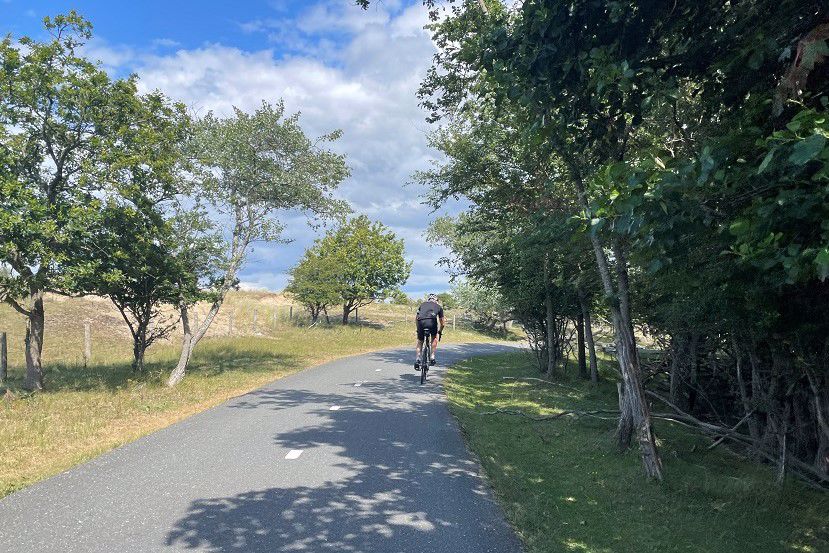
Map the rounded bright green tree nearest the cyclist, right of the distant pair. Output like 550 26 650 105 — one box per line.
319 215 412 324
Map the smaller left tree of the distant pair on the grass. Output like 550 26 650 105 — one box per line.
285 243 340 324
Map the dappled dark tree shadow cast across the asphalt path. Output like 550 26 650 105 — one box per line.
166 342 520 553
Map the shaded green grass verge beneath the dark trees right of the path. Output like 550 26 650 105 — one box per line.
446 354 829 553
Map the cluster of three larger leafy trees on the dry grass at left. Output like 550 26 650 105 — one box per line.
0 12 348 390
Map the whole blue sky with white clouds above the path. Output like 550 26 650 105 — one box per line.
0 0 457 295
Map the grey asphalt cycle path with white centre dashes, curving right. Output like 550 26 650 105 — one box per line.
0 344 521 553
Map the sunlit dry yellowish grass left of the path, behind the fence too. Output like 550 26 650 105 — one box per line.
0 293 504 497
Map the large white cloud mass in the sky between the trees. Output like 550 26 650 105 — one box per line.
106 0 456 292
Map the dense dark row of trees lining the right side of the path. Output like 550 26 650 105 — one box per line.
358 0 829 486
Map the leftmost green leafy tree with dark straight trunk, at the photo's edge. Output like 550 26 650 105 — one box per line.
0 11 141 390
